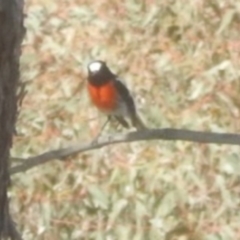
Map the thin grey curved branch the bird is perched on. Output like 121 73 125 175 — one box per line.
10 128 240 174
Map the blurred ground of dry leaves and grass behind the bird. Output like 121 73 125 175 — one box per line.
10 0 240 240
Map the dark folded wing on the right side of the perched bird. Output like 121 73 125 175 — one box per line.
114 78 136 116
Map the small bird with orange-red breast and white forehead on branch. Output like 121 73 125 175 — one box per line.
88 60 146 130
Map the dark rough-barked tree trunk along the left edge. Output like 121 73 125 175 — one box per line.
0 0 24 239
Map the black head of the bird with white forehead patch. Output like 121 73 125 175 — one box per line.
88 60 115 86
